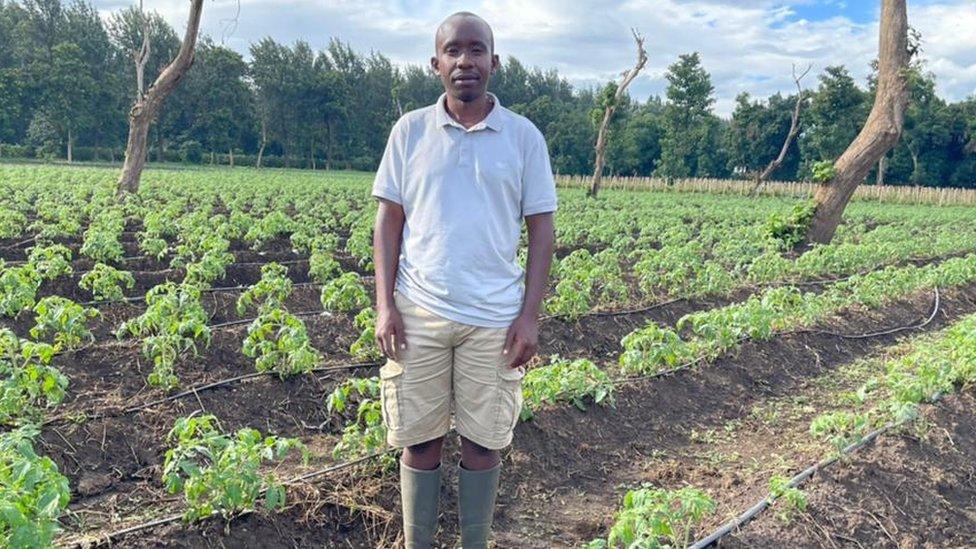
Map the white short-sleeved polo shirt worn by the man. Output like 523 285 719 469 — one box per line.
373 94 556 328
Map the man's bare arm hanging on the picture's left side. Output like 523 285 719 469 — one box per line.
373 198 407 360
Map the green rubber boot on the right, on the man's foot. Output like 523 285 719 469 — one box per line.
458 463 502 549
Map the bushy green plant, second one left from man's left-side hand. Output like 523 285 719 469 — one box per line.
243 308 322 378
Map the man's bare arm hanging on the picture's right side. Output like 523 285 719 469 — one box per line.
503 212 555 368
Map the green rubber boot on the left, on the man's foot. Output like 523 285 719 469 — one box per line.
400 461 441 549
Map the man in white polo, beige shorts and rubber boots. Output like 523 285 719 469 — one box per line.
373 8 556 549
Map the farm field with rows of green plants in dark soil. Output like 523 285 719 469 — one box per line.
0 165 976 547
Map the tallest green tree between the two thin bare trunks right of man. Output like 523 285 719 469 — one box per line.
655 52 718 181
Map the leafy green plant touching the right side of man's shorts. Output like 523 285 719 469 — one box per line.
520 356 613 421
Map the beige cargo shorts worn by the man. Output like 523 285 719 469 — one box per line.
380 292 525 450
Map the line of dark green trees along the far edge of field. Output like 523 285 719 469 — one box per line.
0 0 976 187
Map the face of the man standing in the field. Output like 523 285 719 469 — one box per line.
430 19 498 103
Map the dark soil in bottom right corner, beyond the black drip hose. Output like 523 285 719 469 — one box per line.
721 389 976 548
